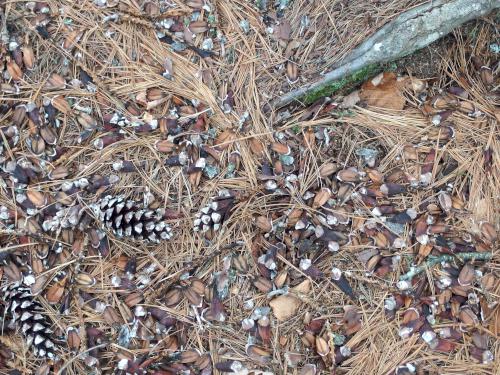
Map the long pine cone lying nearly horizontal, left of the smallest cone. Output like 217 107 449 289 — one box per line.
93 195 172 243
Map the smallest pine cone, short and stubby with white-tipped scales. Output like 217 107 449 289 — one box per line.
194 190 236 233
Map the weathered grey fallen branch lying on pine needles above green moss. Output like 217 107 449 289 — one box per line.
270 0 500 109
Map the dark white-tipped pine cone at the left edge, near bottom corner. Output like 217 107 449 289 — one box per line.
2 282 56 359
